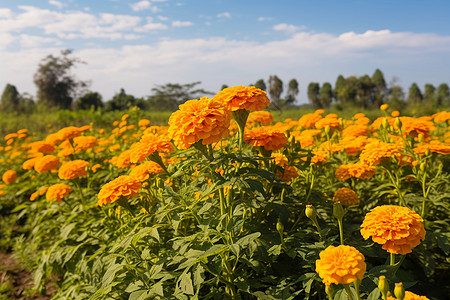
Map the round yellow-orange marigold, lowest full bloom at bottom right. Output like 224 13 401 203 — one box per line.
316 245 366 285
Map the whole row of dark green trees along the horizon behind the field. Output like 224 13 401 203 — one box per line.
0 50 450 113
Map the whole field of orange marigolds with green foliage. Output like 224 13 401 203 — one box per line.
0 86 450 300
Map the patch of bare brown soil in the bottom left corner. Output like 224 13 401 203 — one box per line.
0 253 54 300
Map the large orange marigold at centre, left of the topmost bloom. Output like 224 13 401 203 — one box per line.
169 97 231 149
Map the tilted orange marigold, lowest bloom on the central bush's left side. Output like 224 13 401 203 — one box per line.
97 175 141 206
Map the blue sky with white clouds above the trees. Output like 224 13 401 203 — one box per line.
0 0 450 103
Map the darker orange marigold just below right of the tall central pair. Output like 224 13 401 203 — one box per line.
244 126 288 151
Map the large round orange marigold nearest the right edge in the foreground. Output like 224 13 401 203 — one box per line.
361 205 425 255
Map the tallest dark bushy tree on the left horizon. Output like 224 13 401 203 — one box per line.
33 50 88 109
